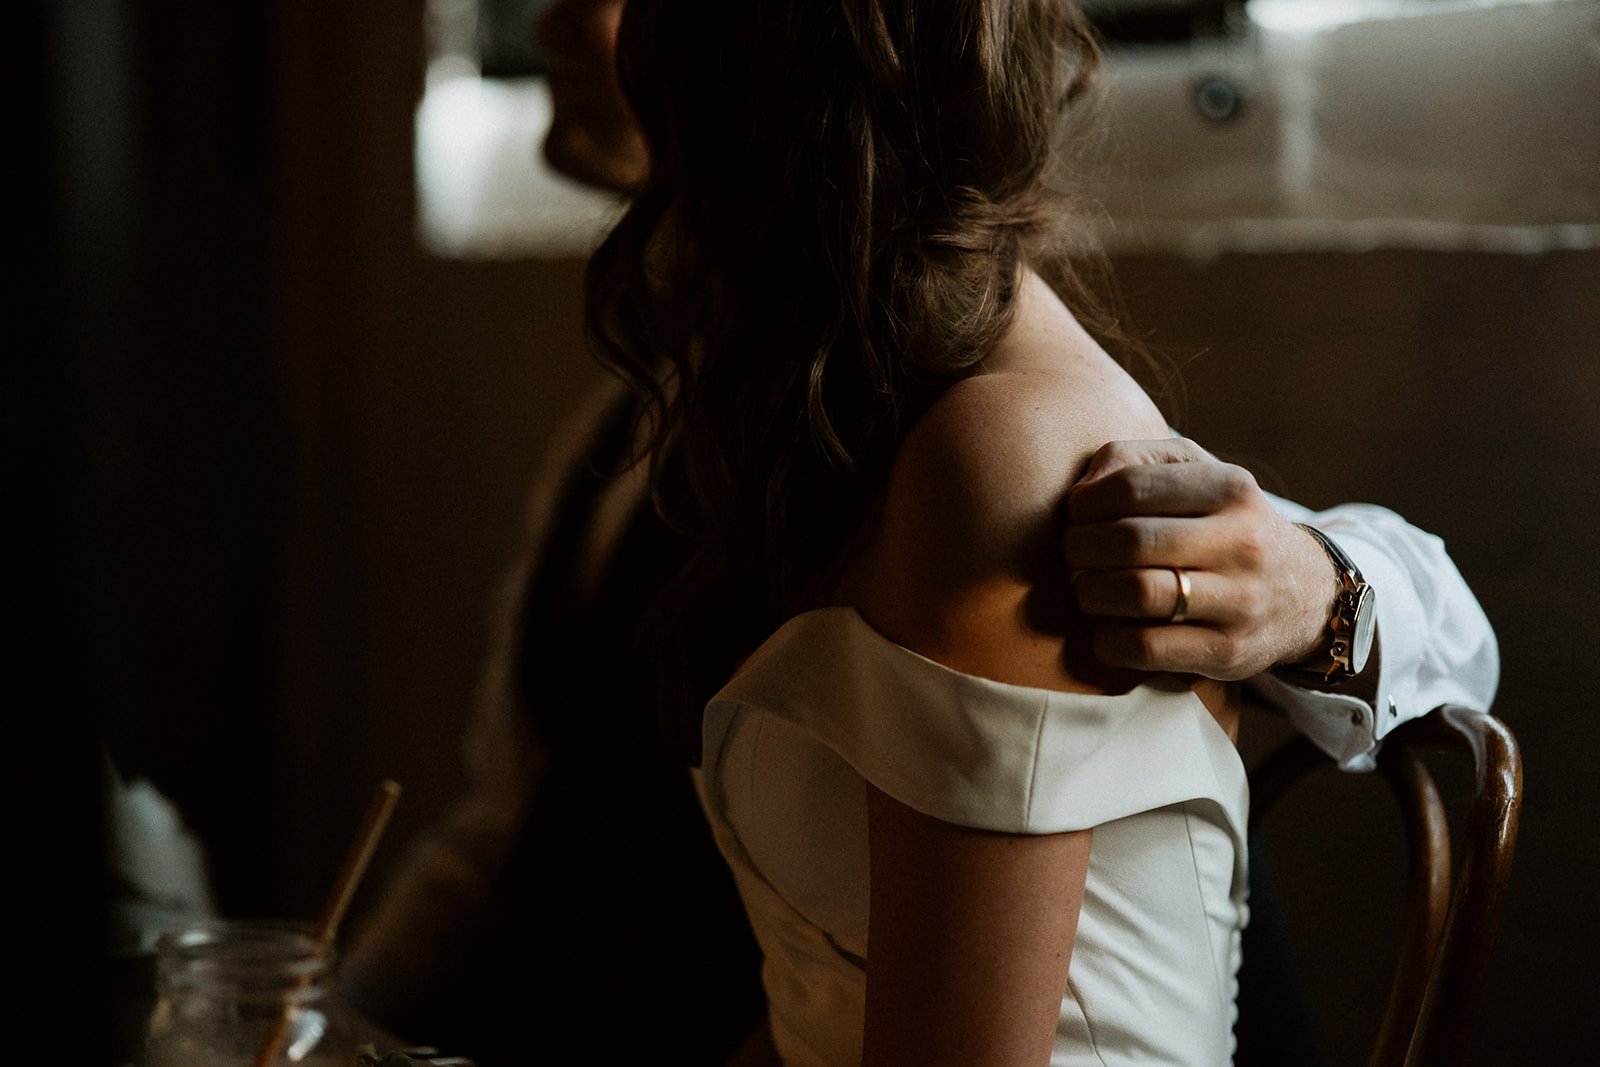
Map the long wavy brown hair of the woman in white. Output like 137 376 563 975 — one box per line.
586 0 1126 758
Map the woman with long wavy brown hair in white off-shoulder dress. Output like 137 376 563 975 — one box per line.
587 0 1245 1065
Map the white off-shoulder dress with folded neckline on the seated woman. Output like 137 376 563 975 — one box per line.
694 608 1248 1067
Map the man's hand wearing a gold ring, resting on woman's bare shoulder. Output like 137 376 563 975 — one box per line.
1062 438 1338 681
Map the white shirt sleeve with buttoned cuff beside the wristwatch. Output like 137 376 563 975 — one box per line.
1251 498 1499 771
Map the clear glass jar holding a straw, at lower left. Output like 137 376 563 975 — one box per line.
138 921 357 1067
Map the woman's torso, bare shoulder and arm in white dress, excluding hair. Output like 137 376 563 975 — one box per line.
698 277 1245 1064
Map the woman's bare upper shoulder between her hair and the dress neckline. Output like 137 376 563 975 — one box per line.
858 278 1166 688
